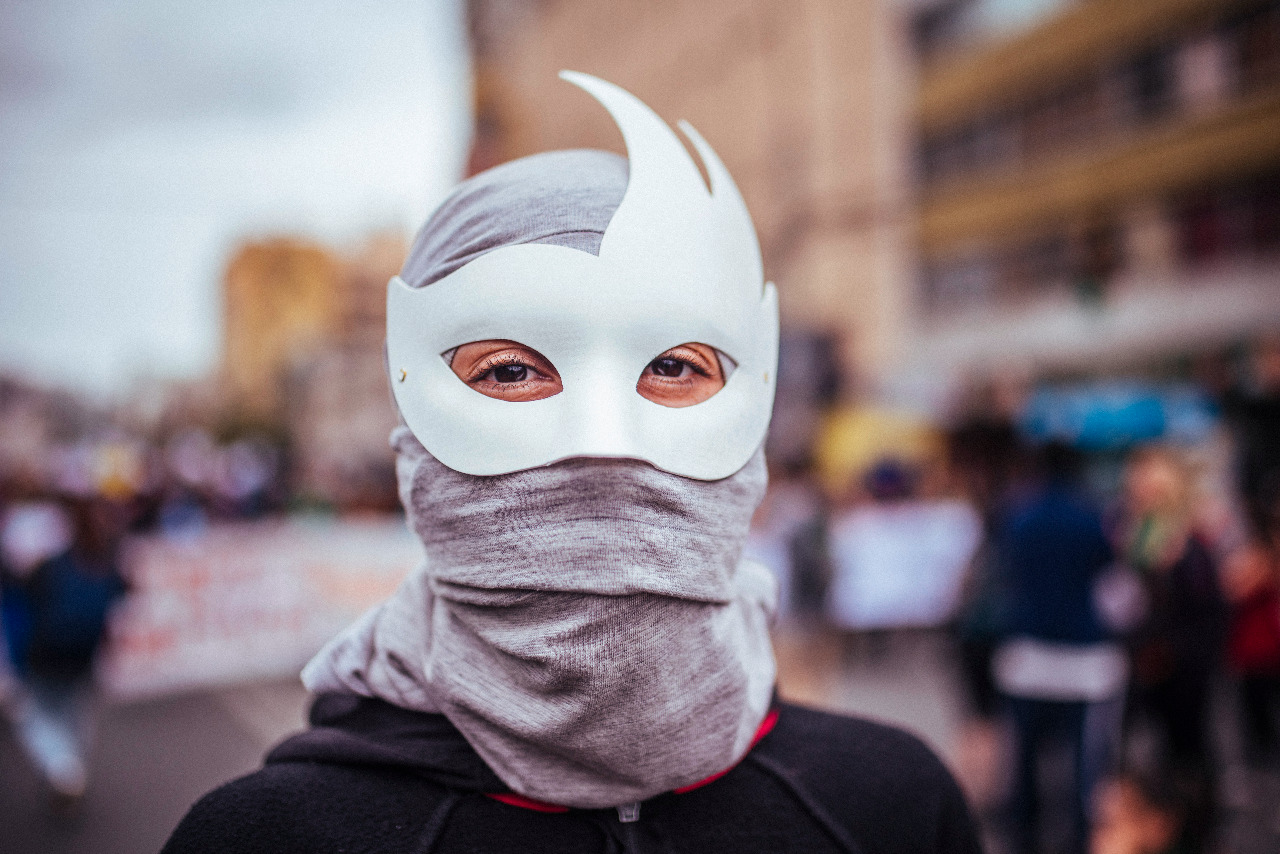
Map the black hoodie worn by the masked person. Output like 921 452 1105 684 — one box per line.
163 694 980 854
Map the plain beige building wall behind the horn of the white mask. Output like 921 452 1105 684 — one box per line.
470 0 914 394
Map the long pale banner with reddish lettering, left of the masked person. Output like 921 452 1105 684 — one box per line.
100 521 421 698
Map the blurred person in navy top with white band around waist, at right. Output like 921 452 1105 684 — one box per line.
993 443 1125 851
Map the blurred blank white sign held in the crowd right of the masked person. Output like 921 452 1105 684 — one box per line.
827 501 980 629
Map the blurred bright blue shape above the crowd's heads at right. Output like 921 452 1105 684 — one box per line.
1021 380 1219 451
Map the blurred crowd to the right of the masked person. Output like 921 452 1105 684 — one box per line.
756 341 1280 854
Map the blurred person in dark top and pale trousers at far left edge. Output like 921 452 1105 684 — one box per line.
0 486 124 800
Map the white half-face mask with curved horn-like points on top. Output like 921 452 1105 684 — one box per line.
387 72 778 480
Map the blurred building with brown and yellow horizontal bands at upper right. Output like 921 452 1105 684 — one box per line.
914 0 1280 375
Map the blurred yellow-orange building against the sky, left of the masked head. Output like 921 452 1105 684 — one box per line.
224 234 406 508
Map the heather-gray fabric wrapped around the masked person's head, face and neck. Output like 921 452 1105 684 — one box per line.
302 152 776 808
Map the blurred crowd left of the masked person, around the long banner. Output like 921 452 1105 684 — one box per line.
0 426 283 805
